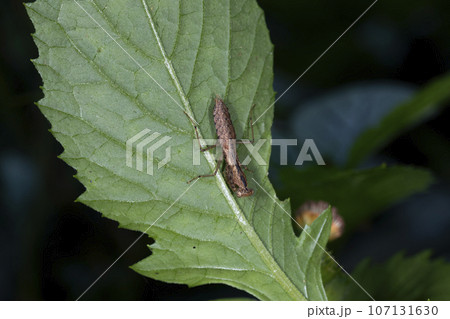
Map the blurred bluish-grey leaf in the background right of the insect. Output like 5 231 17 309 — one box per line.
290 81 414 165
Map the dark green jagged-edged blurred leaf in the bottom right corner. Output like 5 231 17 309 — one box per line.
327 251 450 301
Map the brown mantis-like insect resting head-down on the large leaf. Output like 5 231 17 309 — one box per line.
188 97 254 197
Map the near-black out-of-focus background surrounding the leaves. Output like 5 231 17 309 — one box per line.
0 0 450 300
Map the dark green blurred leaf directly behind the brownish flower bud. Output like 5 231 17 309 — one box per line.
280 166 433 232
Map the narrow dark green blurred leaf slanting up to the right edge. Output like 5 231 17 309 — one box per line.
347 74 450 167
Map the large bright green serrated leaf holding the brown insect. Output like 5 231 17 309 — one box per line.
27 0 329 300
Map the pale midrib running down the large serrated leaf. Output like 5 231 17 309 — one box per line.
141 0 306 300
